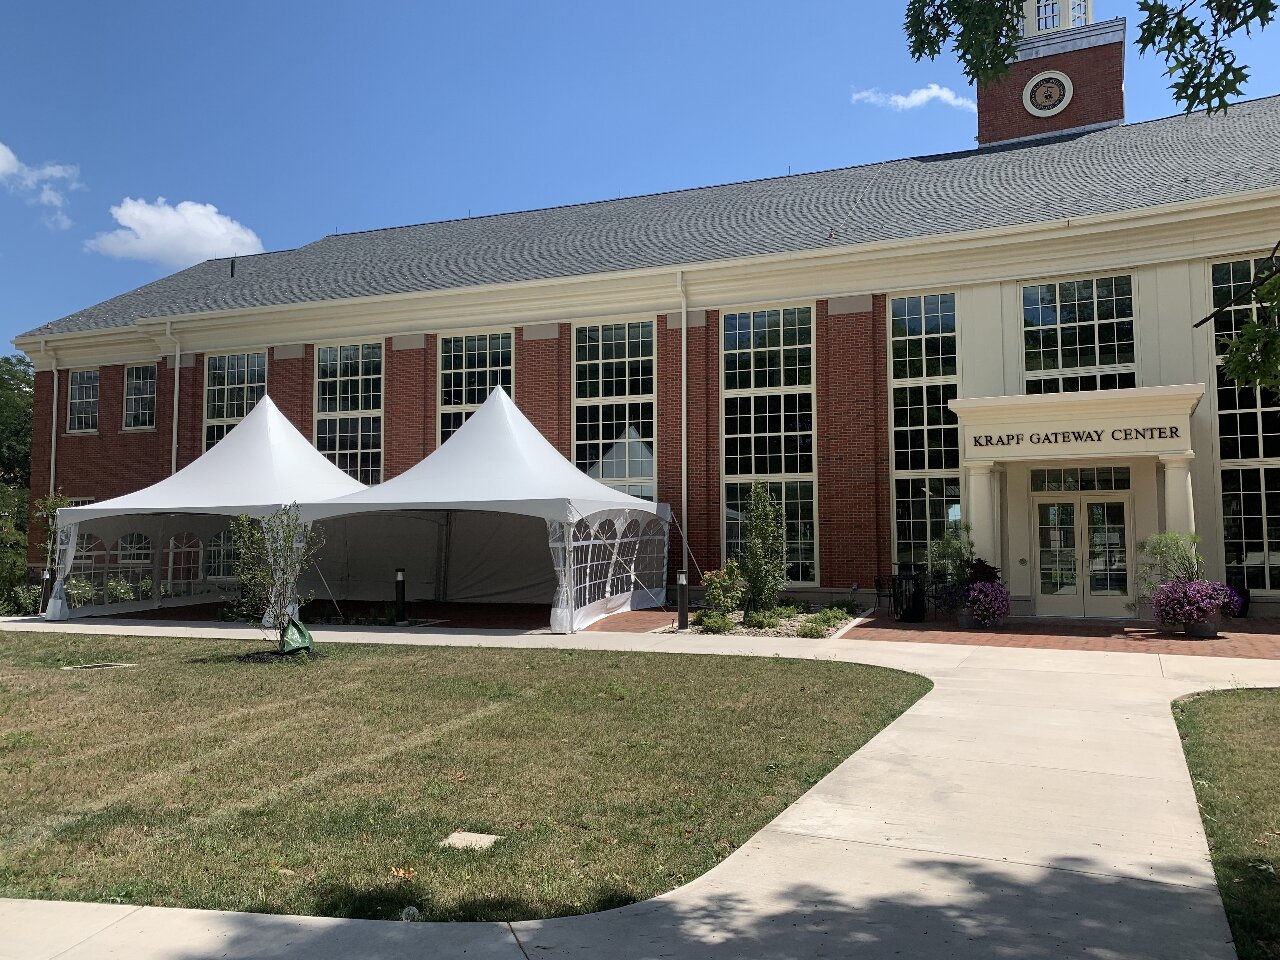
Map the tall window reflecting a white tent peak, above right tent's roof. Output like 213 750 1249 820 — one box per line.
573 320 657 500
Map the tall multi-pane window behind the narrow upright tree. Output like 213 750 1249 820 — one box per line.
723 306 818 584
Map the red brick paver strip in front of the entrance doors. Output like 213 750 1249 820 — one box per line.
845 612 1280 660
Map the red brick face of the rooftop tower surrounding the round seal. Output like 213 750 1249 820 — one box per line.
978 44 1125 143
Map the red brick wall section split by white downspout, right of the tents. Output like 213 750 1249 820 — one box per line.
657 310 721 586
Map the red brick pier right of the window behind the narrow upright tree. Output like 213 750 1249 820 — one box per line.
814 296 891 588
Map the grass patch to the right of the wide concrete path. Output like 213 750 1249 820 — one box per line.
1174 690 1280 960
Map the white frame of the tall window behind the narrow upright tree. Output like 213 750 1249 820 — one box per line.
716 300 822 589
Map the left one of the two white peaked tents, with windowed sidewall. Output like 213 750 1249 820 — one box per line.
45 397 365 620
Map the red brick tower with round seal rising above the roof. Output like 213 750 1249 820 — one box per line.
978 0 1125 146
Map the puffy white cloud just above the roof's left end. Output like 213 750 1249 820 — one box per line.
84 197 262 268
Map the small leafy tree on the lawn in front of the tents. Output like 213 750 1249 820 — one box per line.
232 503 324 650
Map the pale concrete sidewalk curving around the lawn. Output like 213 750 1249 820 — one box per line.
0 622 1280 960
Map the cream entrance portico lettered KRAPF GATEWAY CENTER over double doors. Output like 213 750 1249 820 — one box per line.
950 384 1204 617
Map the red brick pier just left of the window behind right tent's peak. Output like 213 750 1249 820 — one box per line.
383 334 438 480
